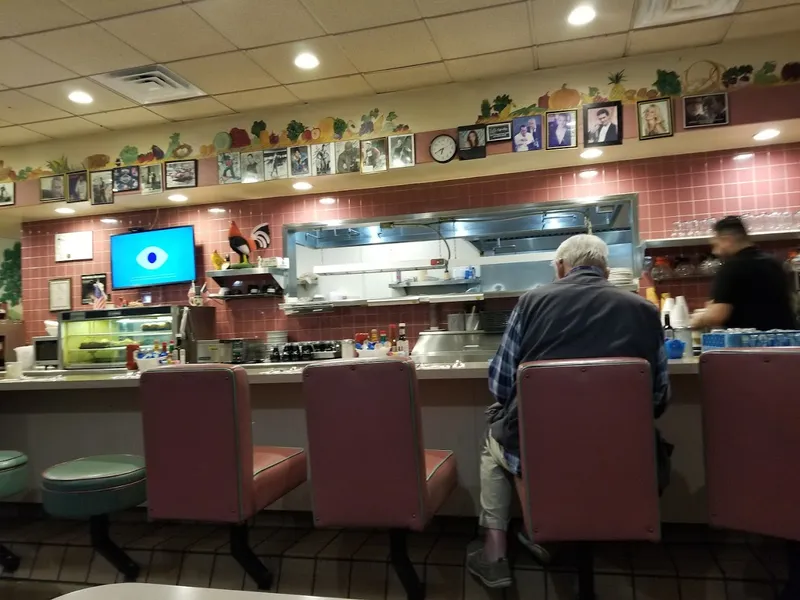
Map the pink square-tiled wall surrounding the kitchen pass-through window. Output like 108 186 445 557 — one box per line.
22 142 800 340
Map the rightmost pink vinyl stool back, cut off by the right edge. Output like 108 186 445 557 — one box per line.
700 348 800 540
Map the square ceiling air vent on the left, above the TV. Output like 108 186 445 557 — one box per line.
92 65 206 104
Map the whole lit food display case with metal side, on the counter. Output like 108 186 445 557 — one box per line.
59 306 216 369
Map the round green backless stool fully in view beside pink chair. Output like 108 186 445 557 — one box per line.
42 454 147 581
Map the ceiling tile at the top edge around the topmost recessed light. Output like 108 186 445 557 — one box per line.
531 0 634 44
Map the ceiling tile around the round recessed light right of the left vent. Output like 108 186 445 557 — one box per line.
247 36 358 83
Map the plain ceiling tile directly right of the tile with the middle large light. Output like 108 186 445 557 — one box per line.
336 21 441 72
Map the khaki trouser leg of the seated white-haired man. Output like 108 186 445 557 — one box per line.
480 434 515 531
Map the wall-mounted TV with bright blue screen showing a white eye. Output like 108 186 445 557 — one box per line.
111 226 197 290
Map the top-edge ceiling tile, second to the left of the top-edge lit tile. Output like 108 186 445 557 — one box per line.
303 0 421 33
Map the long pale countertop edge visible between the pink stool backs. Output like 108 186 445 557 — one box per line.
0 358 699 397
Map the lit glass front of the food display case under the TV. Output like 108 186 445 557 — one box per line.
59 306 182 369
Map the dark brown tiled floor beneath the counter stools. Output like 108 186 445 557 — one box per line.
0 511 786 600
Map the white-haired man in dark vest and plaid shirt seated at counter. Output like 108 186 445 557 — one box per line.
467 235 672 588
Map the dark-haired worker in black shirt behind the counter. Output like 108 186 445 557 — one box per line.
692 217 796 331
